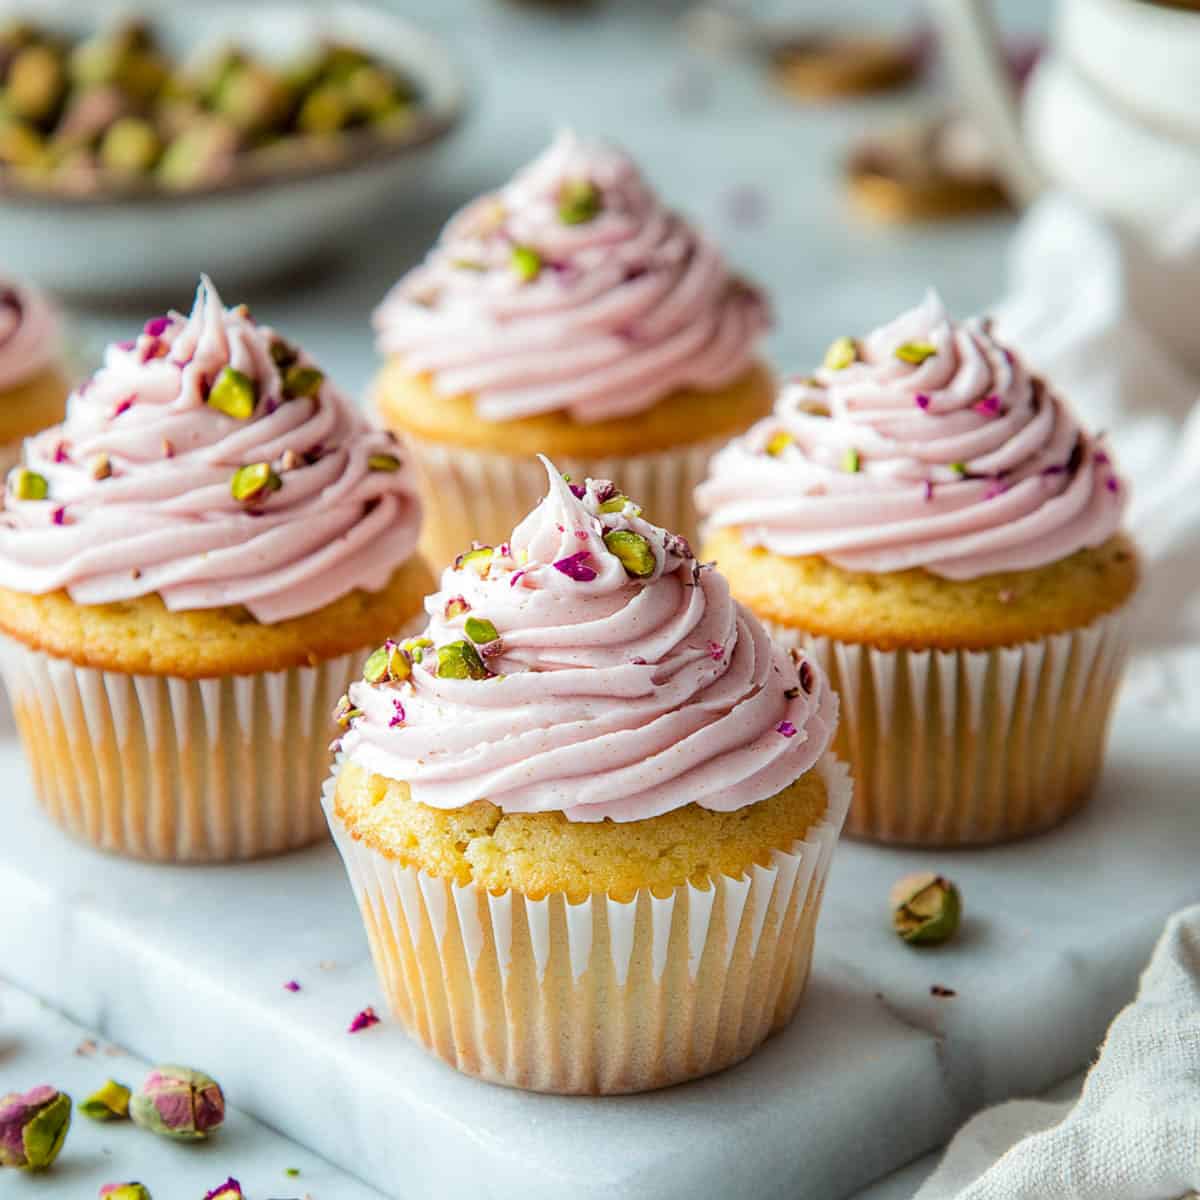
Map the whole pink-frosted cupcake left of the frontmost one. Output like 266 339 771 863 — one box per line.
0 281 432 862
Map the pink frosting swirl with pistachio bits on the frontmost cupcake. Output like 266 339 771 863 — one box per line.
343 460 838 821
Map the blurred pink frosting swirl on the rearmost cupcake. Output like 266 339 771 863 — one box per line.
376 133 768 421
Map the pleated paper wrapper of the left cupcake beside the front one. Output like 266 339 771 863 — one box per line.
0 637 361 863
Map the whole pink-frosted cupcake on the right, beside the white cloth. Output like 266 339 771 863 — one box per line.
697 295 1138 846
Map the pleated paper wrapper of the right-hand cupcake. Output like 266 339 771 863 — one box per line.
763 611 1129 846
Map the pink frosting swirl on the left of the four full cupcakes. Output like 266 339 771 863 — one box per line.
0 280 420 623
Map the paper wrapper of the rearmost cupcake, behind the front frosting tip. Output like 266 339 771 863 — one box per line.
408 437 725 565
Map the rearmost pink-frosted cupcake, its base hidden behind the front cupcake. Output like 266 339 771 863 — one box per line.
374 133 773 563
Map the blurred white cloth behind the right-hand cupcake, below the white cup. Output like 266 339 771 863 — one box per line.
995 194 1200 727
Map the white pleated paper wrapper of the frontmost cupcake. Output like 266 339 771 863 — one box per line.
323 756 851 1094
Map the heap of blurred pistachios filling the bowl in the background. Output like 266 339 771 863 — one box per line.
0 20 420 194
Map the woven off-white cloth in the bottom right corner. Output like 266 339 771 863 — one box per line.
916 905 1200 1200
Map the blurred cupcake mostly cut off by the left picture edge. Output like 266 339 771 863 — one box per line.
0 281 71 472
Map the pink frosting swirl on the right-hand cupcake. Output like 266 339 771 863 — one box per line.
696 285 1126 580
